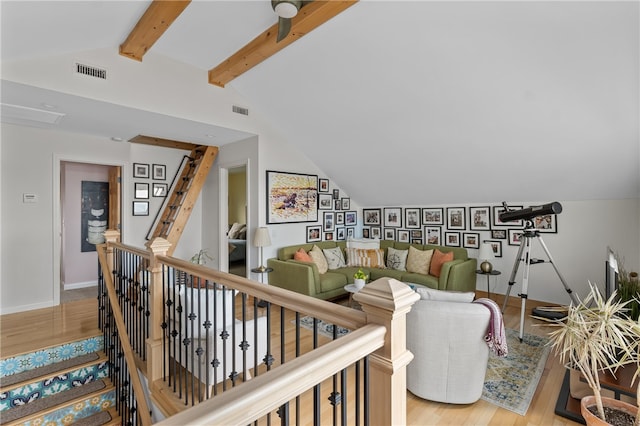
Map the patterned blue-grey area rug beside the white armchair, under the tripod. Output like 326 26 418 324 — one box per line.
482 329 551 416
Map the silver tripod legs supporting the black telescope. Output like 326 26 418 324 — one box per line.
502 220 580 342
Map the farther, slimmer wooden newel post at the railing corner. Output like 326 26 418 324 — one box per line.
146 237 171 387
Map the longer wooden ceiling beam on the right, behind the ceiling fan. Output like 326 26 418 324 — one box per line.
209 0 358 87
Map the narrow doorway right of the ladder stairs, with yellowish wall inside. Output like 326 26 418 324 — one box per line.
227 165 248 277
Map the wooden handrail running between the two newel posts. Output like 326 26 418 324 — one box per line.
158 256 367 330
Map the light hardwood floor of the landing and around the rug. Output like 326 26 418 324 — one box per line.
0 292 578 426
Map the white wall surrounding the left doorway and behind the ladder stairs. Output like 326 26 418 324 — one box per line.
0 124 201 314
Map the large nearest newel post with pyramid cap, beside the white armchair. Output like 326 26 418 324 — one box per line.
353 278 420 425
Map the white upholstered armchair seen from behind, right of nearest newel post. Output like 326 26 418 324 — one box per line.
407 287 490 404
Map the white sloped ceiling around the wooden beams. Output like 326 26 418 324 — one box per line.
0 0 640 206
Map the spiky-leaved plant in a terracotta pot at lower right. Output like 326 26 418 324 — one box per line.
549 283 640 425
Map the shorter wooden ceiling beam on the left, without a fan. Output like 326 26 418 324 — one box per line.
120 0 191 62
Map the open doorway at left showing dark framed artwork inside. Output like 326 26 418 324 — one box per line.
59 161 122 304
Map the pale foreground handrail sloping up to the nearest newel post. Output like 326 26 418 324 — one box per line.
157 324 386 425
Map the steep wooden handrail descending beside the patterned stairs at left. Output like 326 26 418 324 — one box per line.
96 244 151 426
